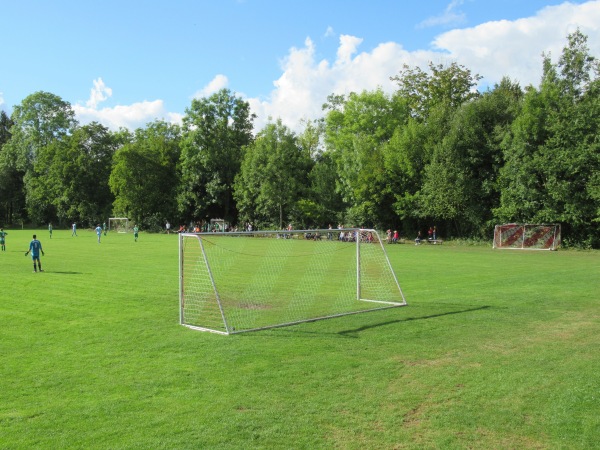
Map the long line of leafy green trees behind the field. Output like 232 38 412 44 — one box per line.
0 30 600 248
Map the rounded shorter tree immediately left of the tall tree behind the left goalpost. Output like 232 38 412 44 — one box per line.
110 121 181 229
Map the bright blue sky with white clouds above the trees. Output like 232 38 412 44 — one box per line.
0 0 600 131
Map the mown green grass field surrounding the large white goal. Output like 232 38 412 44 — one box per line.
0 229 600 449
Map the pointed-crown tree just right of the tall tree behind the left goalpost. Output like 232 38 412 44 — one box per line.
234 119 315 229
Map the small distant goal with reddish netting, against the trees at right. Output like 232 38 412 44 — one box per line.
493 223 560 250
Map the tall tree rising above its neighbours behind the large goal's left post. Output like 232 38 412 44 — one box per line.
178 89 255 223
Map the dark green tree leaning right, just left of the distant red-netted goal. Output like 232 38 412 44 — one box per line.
420 78 522 237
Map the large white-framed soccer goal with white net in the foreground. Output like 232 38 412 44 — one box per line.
179 229 406 334
